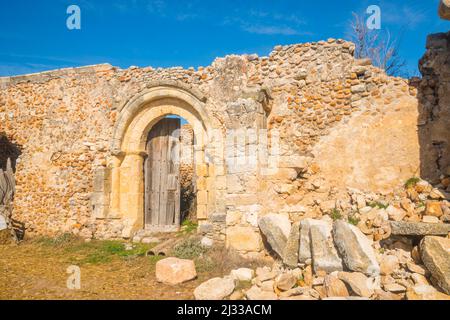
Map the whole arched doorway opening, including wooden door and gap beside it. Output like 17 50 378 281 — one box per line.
144 115 197 232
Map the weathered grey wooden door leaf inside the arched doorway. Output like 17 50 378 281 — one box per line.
144 118 180 232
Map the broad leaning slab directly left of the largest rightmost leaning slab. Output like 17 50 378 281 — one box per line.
309 225 344 273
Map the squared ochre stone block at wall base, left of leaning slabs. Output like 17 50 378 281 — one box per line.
226 226 261 252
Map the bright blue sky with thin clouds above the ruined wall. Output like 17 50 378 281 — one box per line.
0 0 450 76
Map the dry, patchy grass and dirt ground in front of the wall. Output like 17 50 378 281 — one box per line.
0 235 268 300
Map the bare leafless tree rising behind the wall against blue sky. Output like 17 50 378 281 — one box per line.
350 13 406 76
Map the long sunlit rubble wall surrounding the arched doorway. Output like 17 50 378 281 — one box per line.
0 39 420 252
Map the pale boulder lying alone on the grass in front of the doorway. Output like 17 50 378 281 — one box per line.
156 258 197 285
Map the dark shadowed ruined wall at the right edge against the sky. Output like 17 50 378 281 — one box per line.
419 32 450 183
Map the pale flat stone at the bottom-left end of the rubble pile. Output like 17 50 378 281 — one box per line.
194 277 236 300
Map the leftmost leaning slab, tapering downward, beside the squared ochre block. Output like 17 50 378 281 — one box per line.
258 214 291 257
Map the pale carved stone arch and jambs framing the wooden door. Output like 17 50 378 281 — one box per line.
109 83 223 238
